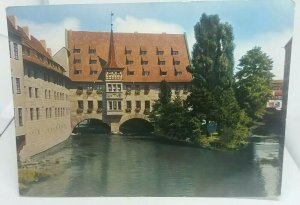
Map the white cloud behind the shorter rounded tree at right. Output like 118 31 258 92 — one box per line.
234 30 292 79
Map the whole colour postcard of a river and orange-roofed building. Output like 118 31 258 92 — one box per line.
7 1 294 197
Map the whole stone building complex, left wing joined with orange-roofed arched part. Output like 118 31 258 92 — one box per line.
8 17 192 158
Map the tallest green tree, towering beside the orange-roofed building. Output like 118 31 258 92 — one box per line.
187 14 248 148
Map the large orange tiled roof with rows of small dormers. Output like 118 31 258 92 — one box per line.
67 31 192 82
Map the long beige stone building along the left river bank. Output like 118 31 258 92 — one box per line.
8 17 71 158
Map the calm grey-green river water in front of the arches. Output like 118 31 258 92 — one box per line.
23 134 282 197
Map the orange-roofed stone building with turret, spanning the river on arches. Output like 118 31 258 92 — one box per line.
66 31 192 133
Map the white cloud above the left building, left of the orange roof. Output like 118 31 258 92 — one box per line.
18 18 80 54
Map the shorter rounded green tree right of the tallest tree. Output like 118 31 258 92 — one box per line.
235 47 273 120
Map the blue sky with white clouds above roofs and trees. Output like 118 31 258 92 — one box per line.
7 0 294 79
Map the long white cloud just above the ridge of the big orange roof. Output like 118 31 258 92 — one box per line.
114 16 184 34
